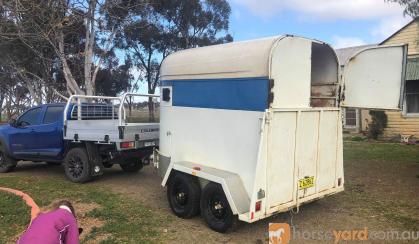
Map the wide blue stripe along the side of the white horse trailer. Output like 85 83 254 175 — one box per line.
161 77 269 111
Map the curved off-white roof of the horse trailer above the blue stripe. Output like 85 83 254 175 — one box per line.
160 35 334 80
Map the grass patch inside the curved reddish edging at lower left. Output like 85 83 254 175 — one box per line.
0 191 31 243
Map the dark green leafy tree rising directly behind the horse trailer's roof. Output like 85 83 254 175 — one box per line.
116 0 233 94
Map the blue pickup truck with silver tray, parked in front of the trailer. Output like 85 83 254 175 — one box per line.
0 94 158 183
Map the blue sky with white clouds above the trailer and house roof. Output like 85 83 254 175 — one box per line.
228 0 411 48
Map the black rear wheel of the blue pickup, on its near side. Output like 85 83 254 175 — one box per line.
64 148 92 183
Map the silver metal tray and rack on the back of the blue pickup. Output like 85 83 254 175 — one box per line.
64 93 159 145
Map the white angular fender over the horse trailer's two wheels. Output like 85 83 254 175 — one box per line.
162 162 250 214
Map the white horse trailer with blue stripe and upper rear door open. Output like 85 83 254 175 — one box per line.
154 35 407 232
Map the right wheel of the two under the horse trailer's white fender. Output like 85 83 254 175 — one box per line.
201 183 237 233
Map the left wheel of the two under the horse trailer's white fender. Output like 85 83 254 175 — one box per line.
167 173 201 219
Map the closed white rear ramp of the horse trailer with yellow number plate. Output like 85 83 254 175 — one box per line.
265 108 344 217
